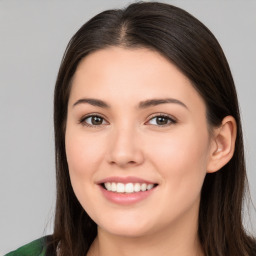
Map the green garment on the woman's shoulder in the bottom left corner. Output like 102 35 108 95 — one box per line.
5 236 48 256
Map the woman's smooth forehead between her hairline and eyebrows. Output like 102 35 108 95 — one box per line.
70 47 204 112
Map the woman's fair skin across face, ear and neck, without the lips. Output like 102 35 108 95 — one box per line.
65 47 236 256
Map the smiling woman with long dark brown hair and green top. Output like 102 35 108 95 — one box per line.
5 3 256 256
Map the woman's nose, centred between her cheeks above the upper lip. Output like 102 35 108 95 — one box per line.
107 127 144 168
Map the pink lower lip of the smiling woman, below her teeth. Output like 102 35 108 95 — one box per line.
99 186 156 205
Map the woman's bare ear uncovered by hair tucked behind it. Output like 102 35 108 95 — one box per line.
207 116 237 173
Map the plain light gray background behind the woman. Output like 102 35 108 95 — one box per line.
0 0 256 254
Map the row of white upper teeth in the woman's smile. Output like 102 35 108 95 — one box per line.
104 182 154 193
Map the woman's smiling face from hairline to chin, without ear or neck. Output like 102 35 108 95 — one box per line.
65 47 213 237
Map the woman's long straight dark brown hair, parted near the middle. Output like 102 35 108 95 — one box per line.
49 2 255 256
